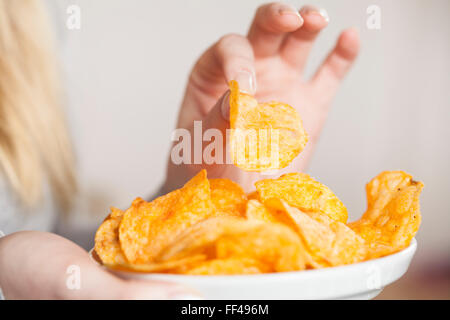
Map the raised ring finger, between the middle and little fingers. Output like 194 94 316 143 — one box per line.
280 6 329 71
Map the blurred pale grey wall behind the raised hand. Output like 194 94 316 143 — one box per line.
47 0 450 295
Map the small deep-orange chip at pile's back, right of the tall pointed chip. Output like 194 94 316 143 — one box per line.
209 179 247 216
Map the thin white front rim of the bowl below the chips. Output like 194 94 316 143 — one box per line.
89 238 417 282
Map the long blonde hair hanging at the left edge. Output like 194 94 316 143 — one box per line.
0 0 76 210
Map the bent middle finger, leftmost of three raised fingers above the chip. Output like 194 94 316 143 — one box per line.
248 3 303 58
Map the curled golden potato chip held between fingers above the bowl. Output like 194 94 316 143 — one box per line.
230 81 308 171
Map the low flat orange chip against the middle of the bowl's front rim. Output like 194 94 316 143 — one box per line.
185 258 262 275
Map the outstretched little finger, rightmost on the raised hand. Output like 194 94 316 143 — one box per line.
311 28 359 102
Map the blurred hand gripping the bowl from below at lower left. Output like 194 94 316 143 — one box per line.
0 231 200 299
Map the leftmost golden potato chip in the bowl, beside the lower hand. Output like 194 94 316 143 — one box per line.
95 207 126 264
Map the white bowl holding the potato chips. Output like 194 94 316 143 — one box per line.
90 239 417 300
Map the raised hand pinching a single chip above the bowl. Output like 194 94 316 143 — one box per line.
163 3 359 192
